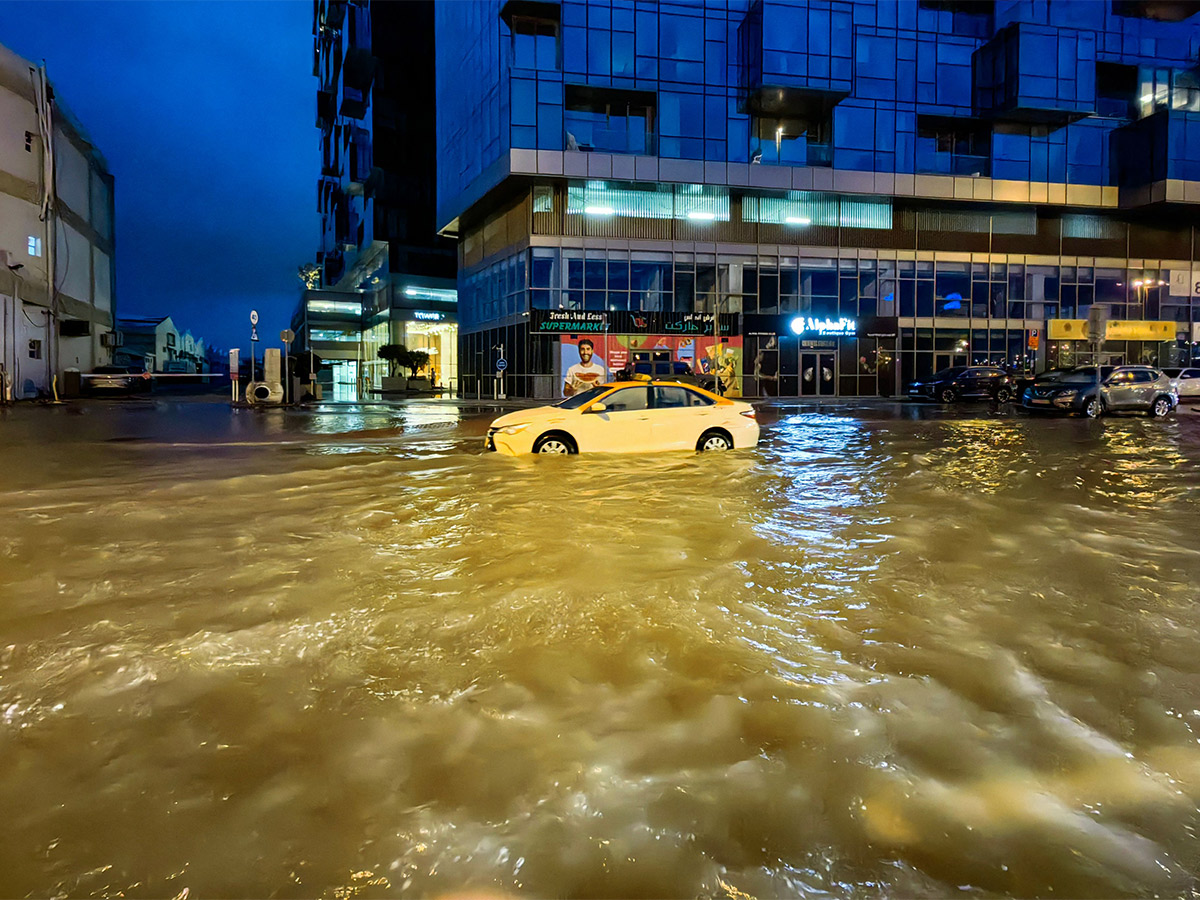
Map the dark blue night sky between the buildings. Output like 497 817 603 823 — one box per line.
0 0 320 348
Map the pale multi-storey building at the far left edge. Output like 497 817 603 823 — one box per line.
0 38 116 398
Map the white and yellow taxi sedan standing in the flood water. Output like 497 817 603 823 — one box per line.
487 382 758 456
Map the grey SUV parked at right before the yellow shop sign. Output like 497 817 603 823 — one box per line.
1021 366 1180 419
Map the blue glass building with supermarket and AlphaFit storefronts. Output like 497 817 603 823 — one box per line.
436 0 1200 397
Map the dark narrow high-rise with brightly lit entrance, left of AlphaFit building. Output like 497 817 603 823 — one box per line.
300 0 458 400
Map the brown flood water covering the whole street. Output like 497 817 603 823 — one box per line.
0 401 1200 900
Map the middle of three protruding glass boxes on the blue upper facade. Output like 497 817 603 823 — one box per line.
972 23 1096 127
